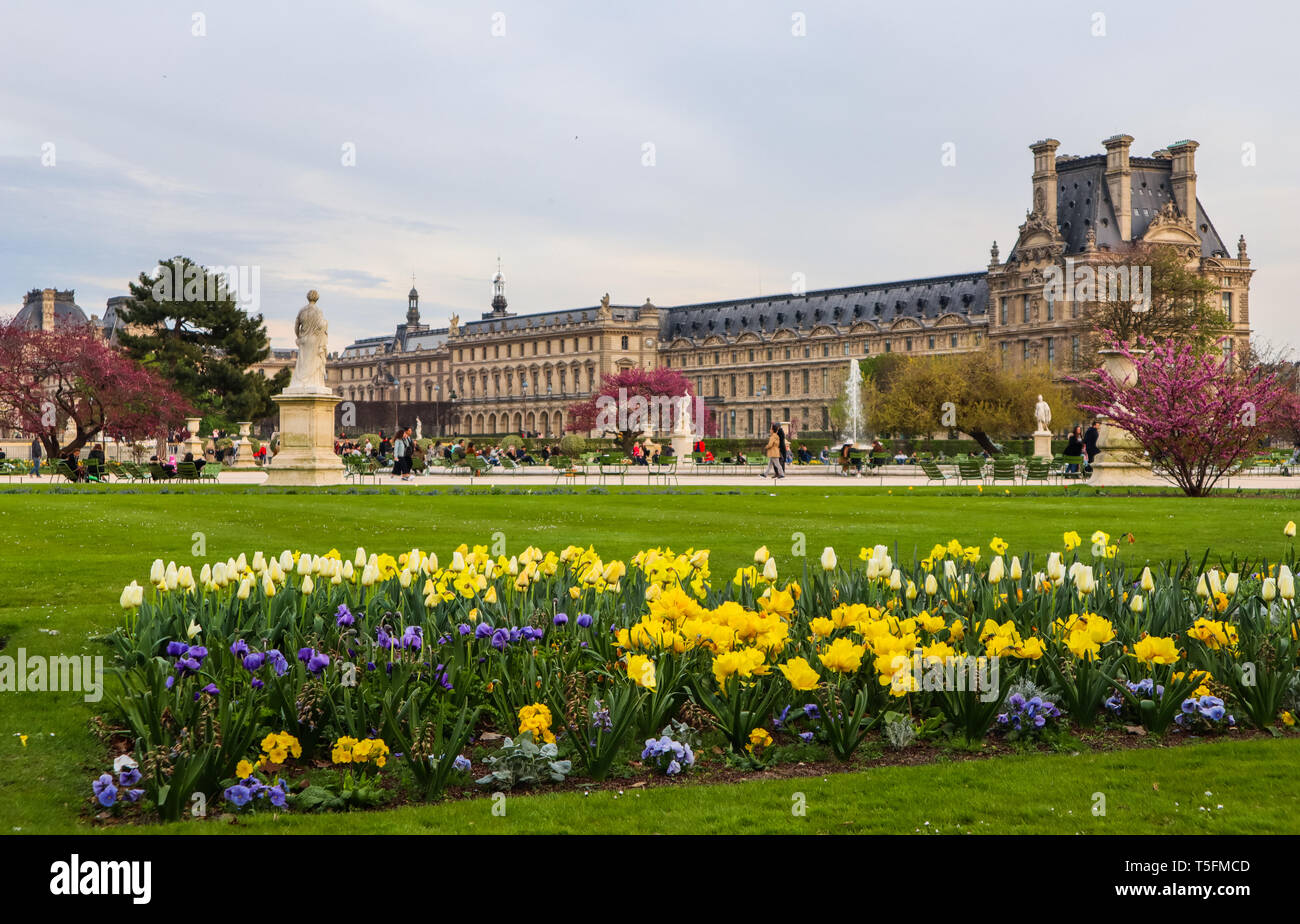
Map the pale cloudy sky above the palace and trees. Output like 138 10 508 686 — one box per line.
0 0 1300 350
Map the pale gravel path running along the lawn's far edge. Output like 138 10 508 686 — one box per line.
9 465 1300 491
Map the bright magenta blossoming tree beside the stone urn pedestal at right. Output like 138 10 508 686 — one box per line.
1074 339 1288 496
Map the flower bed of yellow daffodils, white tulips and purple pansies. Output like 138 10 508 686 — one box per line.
101 532 1300 819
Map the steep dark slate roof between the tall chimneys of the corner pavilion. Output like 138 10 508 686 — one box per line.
1008 155 1229 260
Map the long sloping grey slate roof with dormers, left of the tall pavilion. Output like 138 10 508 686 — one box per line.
659 273 988 340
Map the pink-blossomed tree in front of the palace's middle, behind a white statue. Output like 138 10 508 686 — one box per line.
566 368 715 454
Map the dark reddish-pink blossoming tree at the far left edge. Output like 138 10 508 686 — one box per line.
0 324 190 457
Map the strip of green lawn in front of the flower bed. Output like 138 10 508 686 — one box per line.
109 738 1300 834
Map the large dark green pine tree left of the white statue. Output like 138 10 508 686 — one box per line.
120 256 290 426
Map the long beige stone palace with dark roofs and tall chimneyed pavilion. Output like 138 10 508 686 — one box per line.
328 135 1253 437
